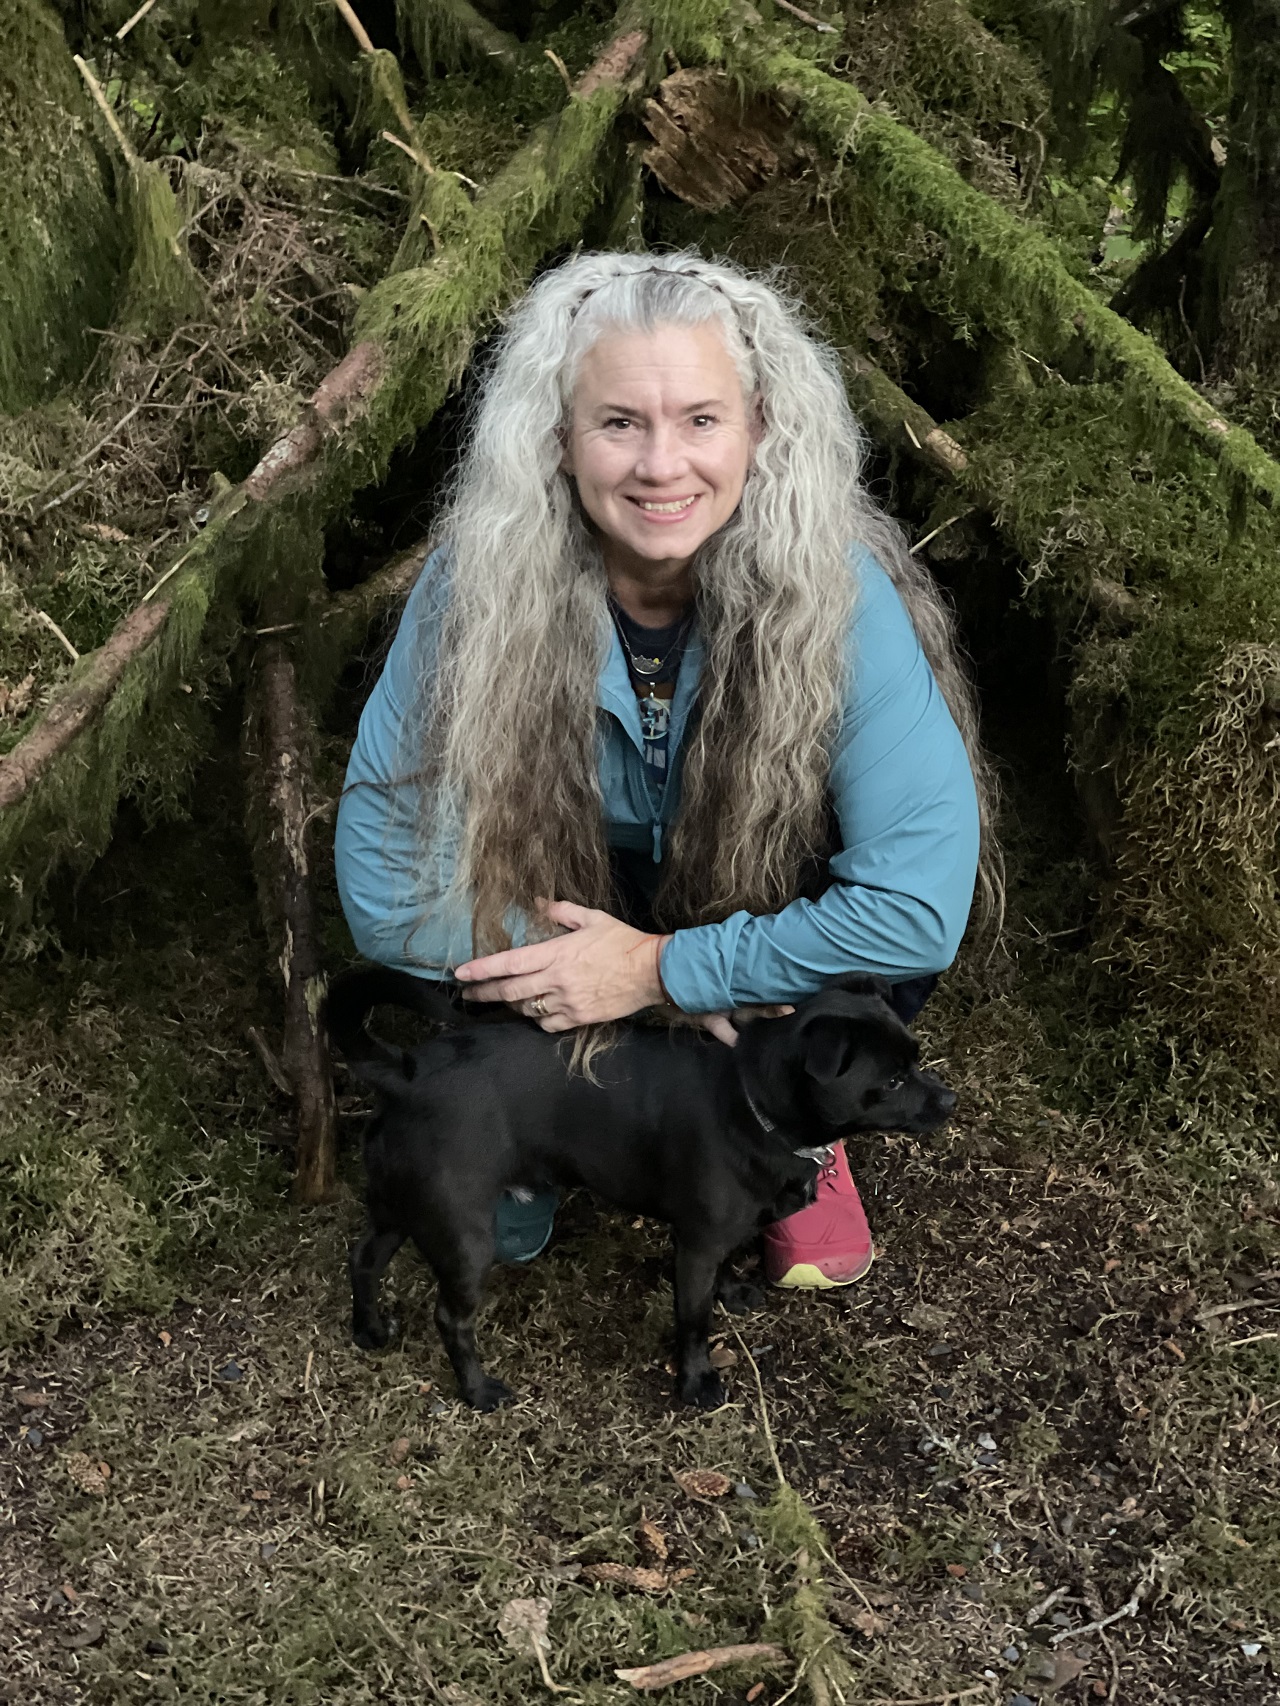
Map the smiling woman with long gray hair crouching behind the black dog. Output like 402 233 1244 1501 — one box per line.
338 254 986 1286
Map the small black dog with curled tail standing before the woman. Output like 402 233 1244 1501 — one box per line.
328 967 956 1409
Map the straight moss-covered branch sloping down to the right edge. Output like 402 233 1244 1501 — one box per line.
722 29 1280 507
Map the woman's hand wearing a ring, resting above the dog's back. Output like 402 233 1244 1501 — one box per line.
454 901 671 1030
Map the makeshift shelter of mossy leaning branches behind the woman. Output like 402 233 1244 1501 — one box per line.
0 0 1280 1196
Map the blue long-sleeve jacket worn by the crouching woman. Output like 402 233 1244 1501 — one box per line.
336 551 978 1013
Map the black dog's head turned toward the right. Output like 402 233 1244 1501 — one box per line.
736 978 956 1138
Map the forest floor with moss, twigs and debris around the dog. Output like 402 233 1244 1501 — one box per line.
0 726 1280 1706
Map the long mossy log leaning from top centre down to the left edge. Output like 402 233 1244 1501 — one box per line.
0 7 649 934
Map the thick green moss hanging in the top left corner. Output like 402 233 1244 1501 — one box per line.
0 0 121 411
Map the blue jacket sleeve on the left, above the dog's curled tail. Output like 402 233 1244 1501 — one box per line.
335 551 471 976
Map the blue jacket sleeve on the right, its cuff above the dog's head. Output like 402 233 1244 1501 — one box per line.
662 554 978 1013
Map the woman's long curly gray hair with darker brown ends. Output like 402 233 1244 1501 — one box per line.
420 252 1000 952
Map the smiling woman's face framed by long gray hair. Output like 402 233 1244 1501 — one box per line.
561 324 759 575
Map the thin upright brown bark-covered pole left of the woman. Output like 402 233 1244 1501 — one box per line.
246 638 338 1203
